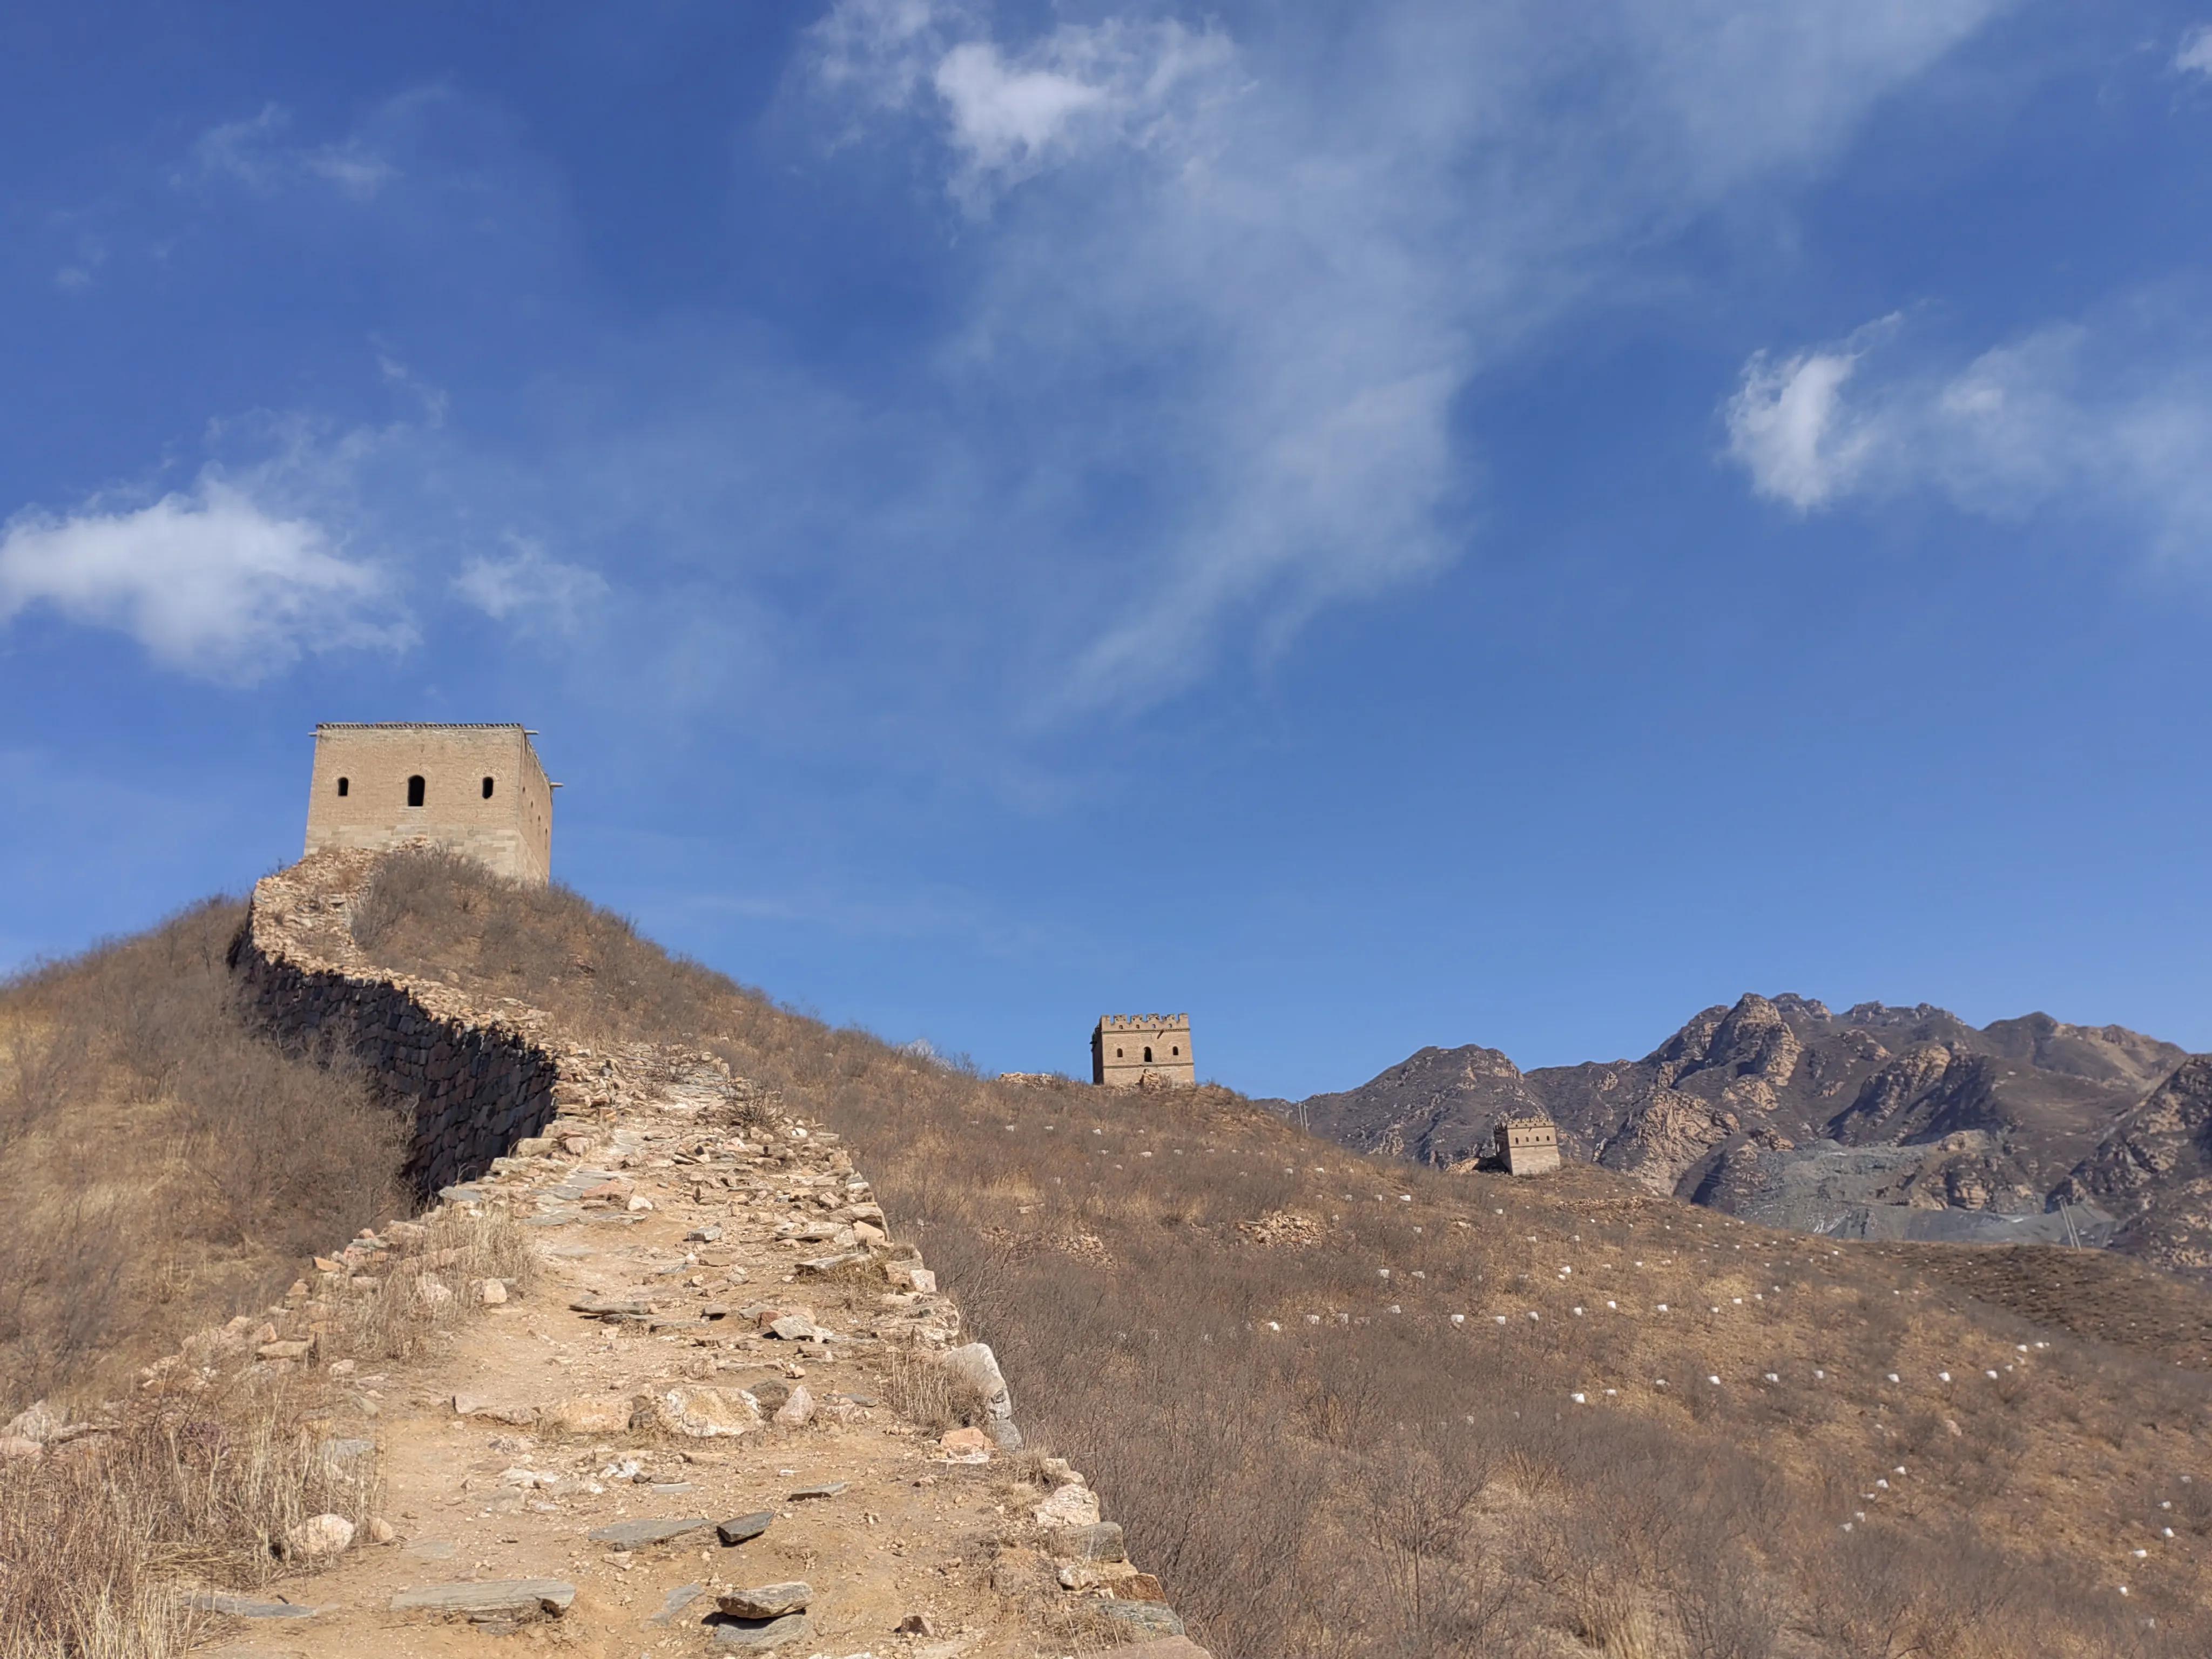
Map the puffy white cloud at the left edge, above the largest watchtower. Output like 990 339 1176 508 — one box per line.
0 469 409 682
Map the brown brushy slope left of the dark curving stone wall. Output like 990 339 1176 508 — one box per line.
0 900 407 1420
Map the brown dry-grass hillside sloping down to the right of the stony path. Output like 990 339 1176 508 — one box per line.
332 860 2212 1659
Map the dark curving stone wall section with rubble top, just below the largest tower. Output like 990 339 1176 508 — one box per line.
230 854 559 1199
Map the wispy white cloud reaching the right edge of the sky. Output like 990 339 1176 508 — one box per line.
1723 294 2212 559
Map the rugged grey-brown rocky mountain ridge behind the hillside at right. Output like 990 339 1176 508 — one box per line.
1290 993 2212 1274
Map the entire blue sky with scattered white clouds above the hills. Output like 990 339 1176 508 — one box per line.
0 0 2212 1095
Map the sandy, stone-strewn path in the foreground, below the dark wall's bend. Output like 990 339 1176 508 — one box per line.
190 1057 1197 1659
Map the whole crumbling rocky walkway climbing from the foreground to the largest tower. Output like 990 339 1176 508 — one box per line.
11 854 1201 1659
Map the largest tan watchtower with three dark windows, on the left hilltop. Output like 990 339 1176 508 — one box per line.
307 721 559 882
